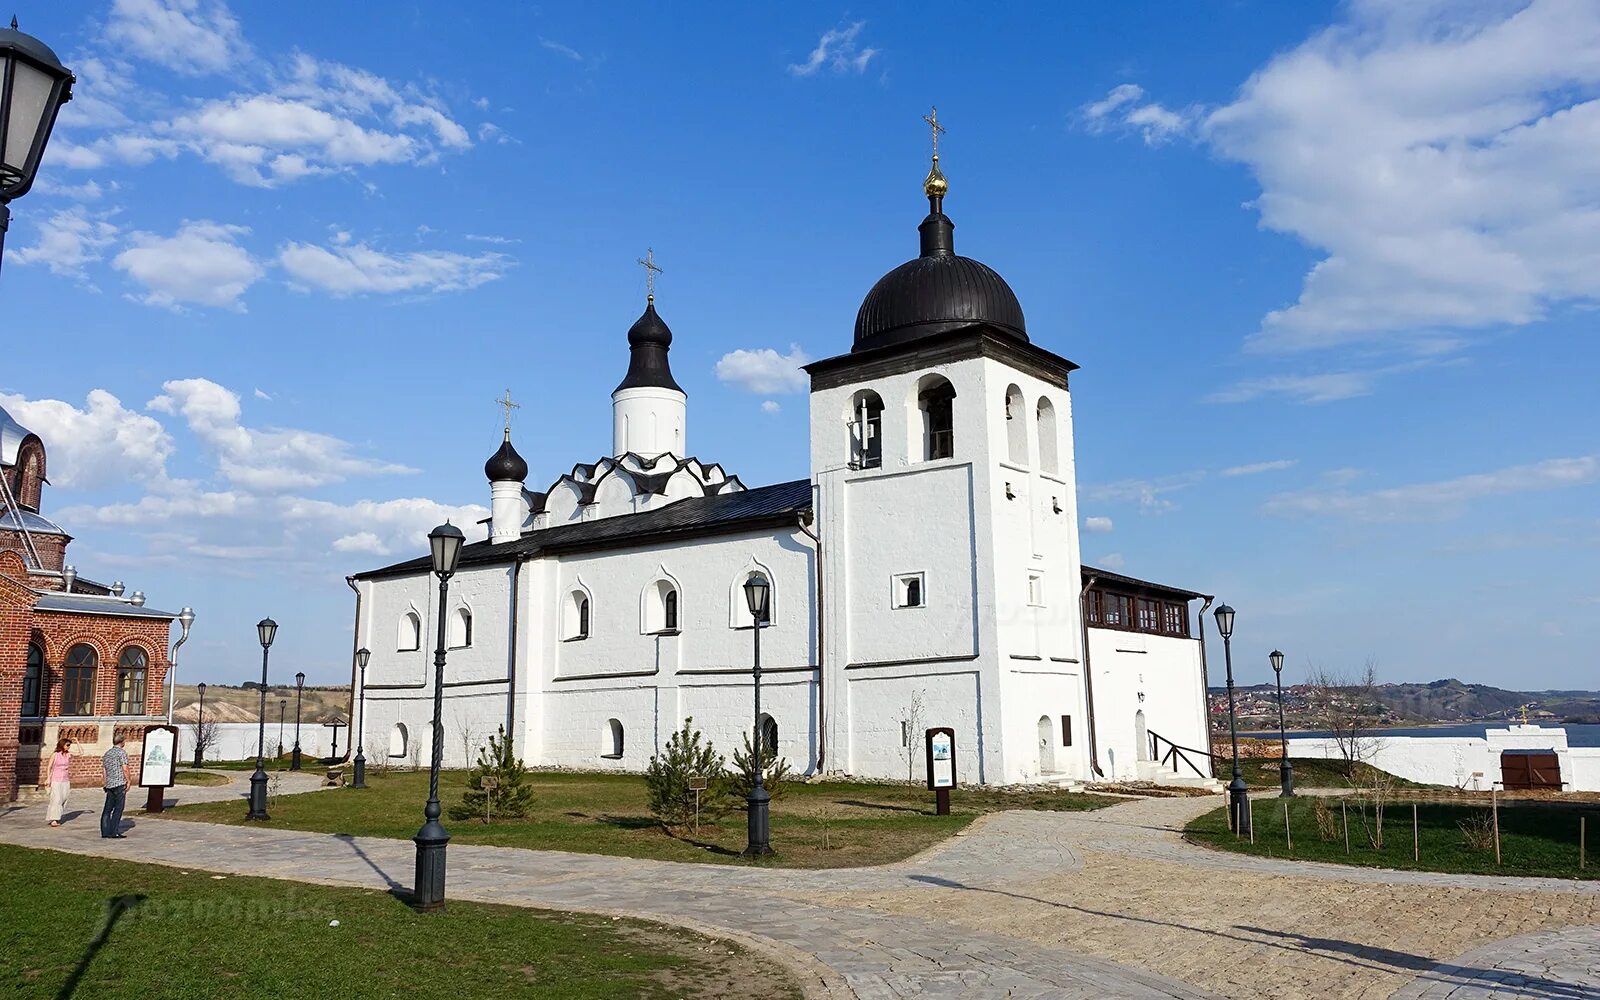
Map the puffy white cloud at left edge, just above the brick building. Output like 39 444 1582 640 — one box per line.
0 389 173 490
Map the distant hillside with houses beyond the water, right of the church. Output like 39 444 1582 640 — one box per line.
1211 677 1600 728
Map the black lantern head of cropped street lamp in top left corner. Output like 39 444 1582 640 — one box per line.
0 18 75 273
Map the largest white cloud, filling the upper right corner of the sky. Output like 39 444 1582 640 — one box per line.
1202 0 1600 349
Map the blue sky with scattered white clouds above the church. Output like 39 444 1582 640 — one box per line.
0 0 1600 688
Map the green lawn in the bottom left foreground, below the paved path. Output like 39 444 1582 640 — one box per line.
0 846 800 1000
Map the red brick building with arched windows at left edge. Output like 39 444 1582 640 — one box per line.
0 401 176 802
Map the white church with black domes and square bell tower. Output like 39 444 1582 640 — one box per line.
350 148 1210 784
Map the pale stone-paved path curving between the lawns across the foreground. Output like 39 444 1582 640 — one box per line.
0 774 1600 1000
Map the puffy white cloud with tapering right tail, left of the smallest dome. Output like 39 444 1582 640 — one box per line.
147 379 413 493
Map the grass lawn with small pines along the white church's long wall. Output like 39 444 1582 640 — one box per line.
166 771 1117 867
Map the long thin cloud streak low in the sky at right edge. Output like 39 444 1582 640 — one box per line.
1262 454 1600 522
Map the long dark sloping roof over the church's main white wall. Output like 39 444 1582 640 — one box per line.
355 478 811 579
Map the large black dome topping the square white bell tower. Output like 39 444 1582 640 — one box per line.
851 194 1027 350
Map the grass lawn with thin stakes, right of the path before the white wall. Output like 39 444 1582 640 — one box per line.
1184 797 1600 878
